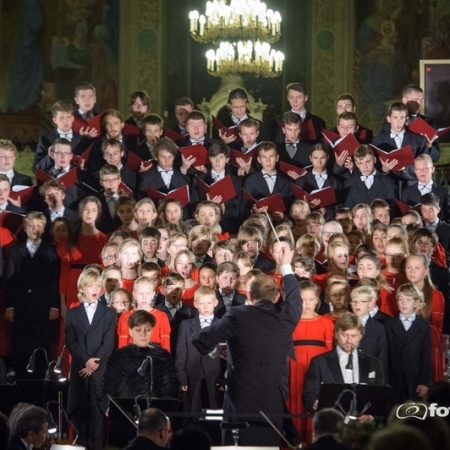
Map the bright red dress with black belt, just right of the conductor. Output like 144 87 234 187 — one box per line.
287 316 334 442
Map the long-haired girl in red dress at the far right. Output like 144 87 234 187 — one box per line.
405 253 447 381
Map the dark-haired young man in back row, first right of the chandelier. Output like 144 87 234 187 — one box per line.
270 83 327 144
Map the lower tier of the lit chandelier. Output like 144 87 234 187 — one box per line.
206 41 284 78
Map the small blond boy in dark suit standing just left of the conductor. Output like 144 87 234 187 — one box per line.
175 286 222 412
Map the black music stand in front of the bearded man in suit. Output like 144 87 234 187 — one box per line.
317 383 392 416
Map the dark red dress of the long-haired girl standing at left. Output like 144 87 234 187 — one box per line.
56 232 108 307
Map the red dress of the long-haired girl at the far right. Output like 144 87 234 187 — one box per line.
420 289 445 382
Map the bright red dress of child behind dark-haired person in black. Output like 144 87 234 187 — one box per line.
117 309 170 352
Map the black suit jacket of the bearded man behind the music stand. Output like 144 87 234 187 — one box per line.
302 349 385 413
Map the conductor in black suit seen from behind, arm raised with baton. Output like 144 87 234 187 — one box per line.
192 247 302 445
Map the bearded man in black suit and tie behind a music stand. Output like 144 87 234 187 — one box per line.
302 313 385 413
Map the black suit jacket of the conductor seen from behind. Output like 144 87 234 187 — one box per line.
192 274 302 426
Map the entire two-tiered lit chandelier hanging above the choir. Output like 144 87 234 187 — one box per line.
189 0 284 78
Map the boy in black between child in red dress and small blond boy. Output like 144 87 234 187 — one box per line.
155 272 196 358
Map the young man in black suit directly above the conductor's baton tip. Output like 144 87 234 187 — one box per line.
244 141 294 220
